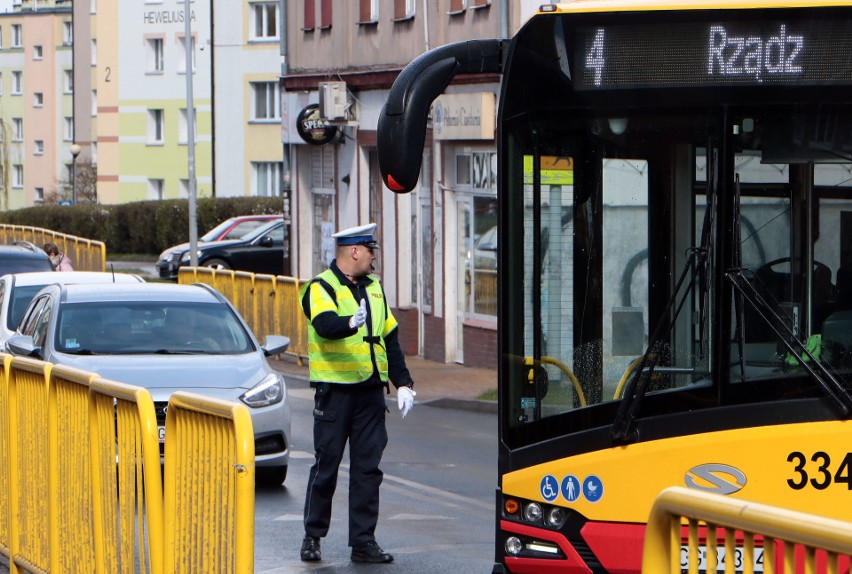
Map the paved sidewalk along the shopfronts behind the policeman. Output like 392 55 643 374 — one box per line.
269 355 497 413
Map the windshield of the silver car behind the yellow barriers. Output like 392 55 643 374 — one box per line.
55 301 255 355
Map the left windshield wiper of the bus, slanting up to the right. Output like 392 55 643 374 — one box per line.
610 141 718 443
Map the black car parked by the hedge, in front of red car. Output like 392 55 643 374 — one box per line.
157 219 286 279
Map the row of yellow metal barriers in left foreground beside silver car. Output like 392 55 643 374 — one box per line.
0 354 255 574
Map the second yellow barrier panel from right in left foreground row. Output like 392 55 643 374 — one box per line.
89 379 164 574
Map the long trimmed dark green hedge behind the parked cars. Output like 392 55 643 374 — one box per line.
0 197 284 255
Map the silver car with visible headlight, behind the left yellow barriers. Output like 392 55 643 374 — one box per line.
8 283 290 484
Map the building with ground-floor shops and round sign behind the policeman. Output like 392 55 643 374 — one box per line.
281 0 539 367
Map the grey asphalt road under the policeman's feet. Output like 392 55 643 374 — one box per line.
255 388 497 574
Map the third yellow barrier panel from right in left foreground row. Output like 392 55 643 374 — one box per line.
47 365 97 572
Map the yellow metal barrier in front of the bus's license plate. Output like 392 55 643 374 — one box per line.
642 487 852 574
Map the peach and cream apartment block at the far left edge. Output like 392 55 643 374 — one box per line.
0 0 73 209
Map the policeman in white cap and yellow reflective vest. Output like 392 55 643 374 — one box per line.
300 223 415 563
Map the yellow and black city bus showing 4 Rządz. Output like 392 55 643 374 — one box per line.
378 0 852 573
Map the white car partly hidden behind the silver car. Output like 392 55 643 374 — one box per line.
0 271 145 352
